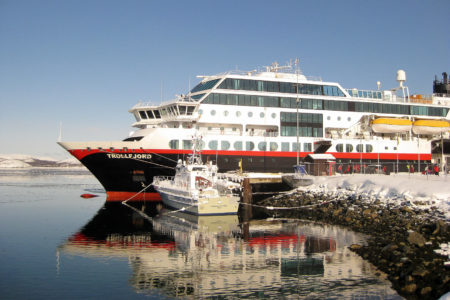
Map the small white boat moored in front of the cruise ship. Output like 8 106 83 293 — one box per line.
153 136 240 215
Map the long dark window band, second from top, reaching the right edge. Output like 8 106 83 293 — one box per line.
202 93 449 117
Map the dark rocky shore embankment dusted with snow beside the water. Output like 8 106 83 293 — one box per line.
257 189 450 299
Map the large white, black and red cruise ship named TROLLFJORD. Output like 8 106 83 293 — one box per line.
59 61 450 201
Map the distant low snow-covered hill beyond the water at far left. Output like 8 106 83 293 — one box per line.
0 154 83 169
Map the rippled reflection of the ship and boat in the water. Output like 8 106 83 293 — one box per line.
60 203 400 299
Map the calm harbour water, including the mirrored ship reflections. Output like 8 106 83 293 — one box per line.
0 170 400 299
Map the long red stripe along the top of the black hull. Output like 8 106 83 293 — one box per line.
70 149 431 160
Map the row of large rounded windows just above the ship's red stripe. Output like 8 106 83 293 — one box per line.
169 140 312 152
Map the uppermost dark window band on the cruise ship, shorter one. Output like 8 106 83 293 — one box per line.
218 78 345 97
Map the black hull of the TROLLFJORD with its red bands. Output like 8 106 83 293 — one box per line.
69 149 431 201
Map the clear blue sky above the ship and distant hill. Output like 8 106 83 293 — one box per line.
0 0 450 156
